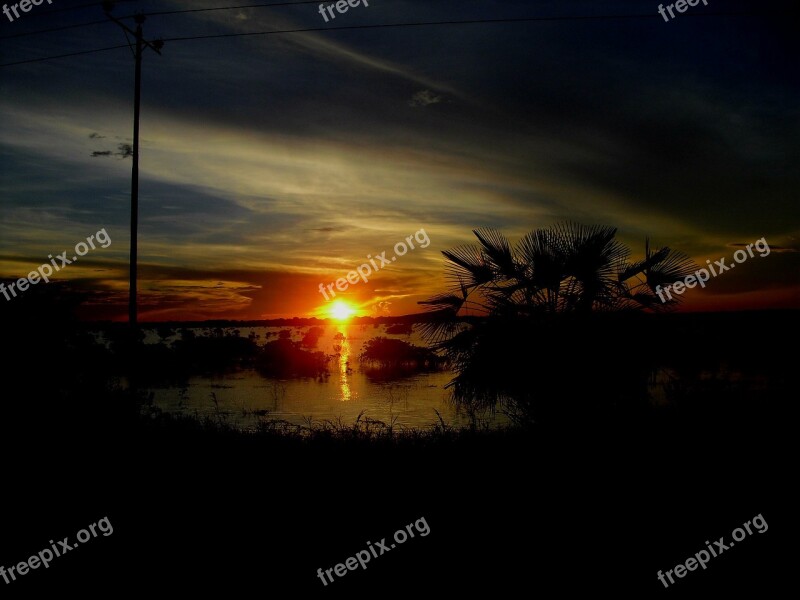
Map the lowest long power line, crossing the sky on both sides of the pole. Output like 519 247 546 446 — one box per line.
0 10 787 67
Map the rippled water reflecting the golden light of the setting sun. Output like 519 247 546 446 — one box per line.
141 321 506 430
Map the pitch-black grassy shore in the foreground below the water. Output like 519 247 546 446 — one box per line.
0 310 797 598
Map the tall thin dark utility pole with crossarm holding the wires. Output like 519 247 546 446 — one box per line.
103 0 164 343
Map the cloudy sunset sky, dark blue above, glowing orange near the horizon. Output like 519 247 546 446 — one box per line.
0 0 800 320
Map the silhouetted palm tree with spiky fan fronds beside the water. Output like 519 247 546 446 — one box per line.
420 223 697 418
